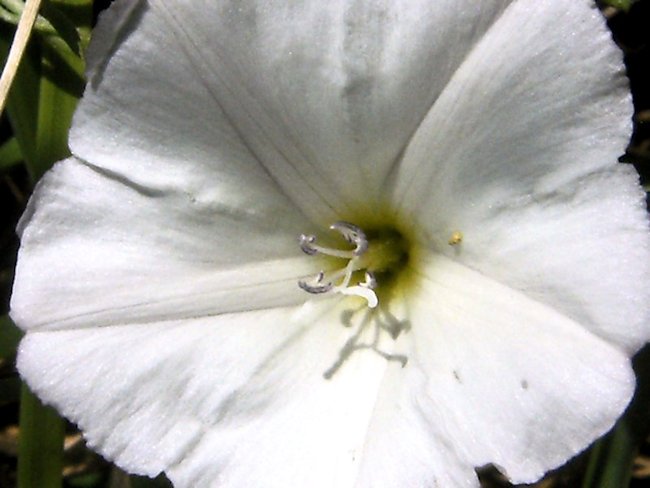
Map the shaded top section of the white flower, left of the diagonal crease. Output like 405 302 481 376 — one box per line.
71 0 508 219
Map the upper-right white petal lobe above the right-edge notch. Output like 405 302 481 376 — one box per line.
395 0 632 212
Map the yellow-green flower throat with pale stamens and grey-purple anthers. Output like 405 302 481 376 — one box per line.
298 221 408 308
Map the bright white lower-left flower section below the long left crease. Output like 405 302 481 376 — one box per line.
18 301 386 487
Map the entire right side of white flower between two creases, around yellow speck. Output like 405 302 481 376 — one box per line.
395 0 650 352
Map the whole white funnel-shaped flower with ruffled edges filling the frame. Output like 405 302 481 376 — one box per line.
12 0 650 488
